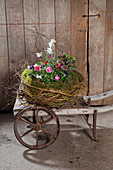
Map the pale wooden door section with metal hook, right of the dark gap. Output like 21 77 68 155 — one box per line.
88 0 113 105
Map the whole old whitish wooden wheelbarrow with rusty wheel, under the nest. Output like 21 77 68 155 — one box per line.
13 90 113 150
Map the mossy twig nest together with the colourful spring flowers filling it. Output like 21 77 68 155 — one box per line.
22 39 84 107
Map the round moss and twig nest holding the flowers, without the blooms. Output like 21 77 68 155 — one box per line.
19 71 85 108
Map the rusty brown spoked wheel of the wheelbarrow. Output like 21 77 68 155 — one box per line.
14 106 60 150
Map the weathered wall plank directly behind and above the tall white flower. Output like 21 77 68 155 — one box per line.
39 0 55 52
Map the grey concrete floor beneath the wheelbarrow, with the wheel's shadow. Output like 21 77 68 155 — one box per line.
0 112 113 170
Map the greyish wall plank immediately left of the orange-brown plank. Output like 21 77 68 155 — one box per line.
55 0 71 55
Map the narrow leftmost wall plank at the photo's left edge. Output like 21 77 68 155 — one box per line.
0 0 9 110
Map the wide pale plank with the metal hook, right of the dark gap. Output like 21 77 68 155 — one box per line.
89 0 106 105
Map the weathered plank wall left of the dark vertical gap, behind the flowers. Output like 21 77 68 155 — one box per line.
0 0 87 109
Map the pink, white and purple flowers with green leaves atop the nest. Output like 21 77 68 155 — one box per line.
27 39 76 83
